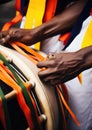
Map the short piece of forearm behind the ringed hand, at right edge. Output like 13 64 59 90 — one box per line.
77 46 92 70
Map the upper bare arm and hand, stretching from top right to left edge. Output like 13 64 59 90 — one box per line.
0 0 87 45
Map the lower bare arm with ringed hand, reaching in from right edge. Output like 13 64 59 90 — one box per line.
38 46 92 85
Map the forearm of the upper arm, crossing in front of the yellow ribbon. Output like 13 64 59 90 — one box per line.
34 0 87 41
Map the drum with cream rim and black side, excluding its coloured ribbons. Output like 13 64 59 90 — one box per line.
0 46 63 130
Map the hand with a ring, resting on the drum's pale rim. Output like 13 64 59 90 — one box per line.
37 52 83 85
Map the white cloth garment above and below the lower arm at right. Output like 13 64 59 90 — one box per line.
66 16 92 130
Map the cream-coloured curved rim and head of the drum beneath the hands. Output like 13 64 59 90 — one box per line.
0 46 62 130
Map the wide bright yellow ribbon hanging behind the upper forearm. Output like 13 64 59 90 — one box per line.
24 0 46 50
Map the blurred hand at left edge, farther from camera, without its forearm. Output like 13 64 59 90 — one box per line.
0 28 35 45
